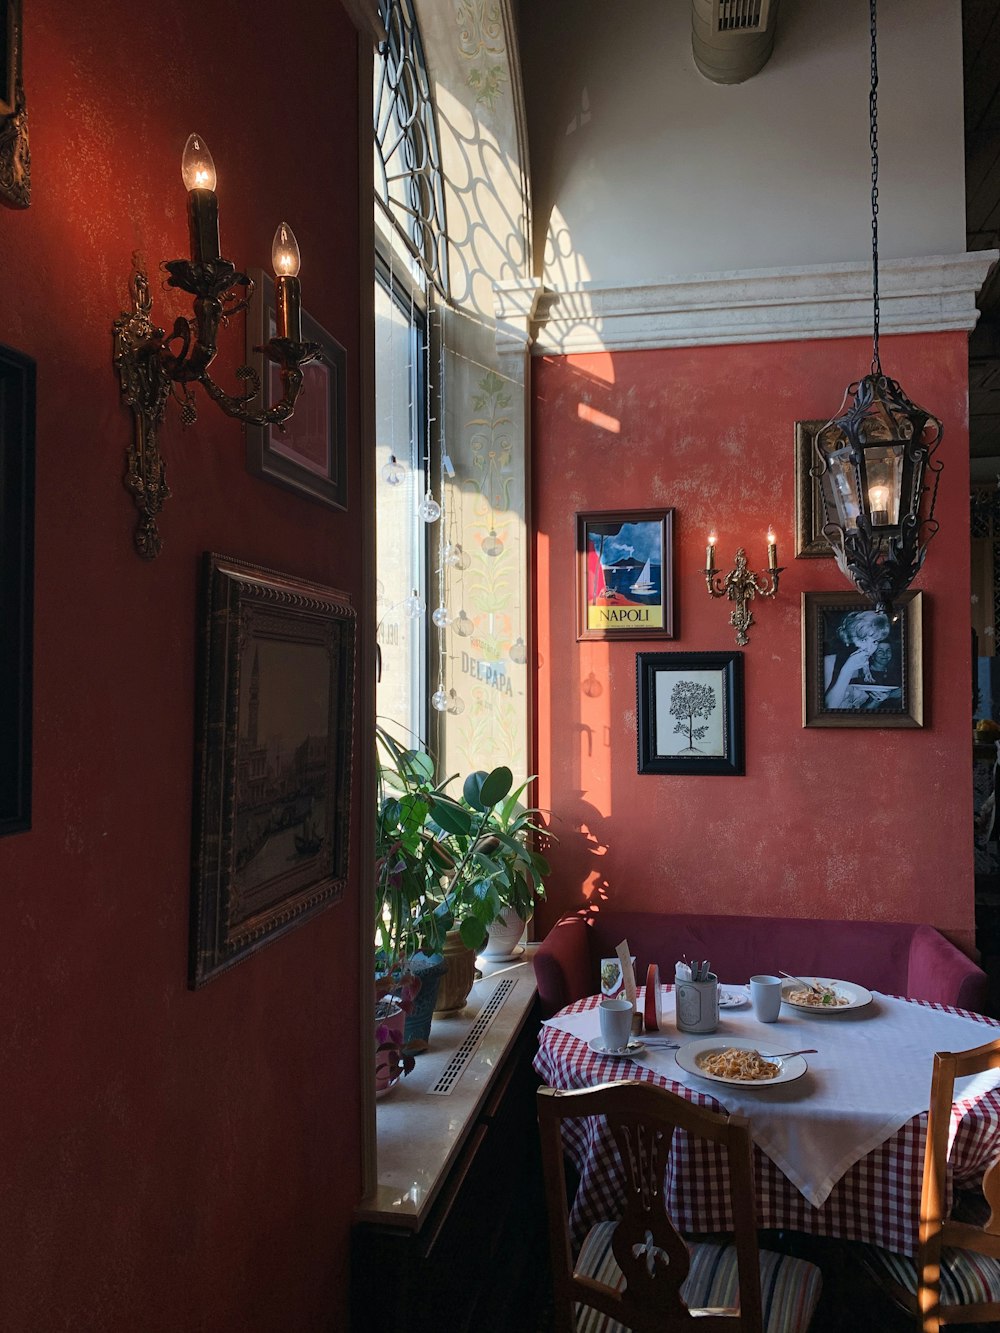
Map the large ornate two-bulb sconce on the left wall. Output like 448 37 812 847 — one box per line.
113 135 320 560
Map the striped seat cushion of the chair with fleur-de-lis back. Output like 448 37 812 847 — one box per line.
576 1222 823 1333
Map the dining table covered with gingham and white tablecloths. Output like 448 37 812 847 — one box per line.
533 985 1000 1256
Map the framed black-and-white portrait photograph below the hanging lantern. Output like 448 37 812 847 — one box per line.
803 592 924 726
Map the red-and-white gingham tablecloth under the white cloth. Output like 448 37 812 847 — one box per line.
535 996 1000 1254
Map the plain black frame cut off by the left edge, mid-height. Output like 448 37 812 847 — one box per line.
0 347 35 834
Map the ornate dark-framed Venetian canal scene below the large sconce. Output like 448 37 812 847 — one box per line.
189 555 355 986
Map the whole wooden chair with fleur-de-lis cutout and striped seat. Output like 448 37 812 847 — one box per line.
537 1081 821 1333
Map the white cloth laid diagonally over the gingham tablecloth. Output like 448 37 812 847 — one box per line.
547 990 1000 1206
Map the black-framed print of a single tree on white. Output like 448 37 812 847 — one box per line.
636 652 744 777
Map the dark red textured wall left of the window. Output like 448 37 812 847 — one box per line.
0 0 361 1333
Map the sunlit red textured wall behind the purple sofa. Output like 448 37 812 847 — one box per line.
533 333 973 944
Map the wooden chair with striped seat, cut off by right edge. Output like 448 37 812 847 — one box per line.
865 1040 1000 1333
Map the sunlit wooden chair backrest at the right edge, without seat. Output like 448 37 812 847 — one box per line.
916 1040 1000 1333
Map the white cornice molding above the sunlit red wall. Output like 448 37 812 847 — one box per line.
525 249 1000 355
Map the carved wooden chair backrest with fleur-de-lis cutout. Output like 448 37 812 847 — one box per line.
537 1081 763 1333
